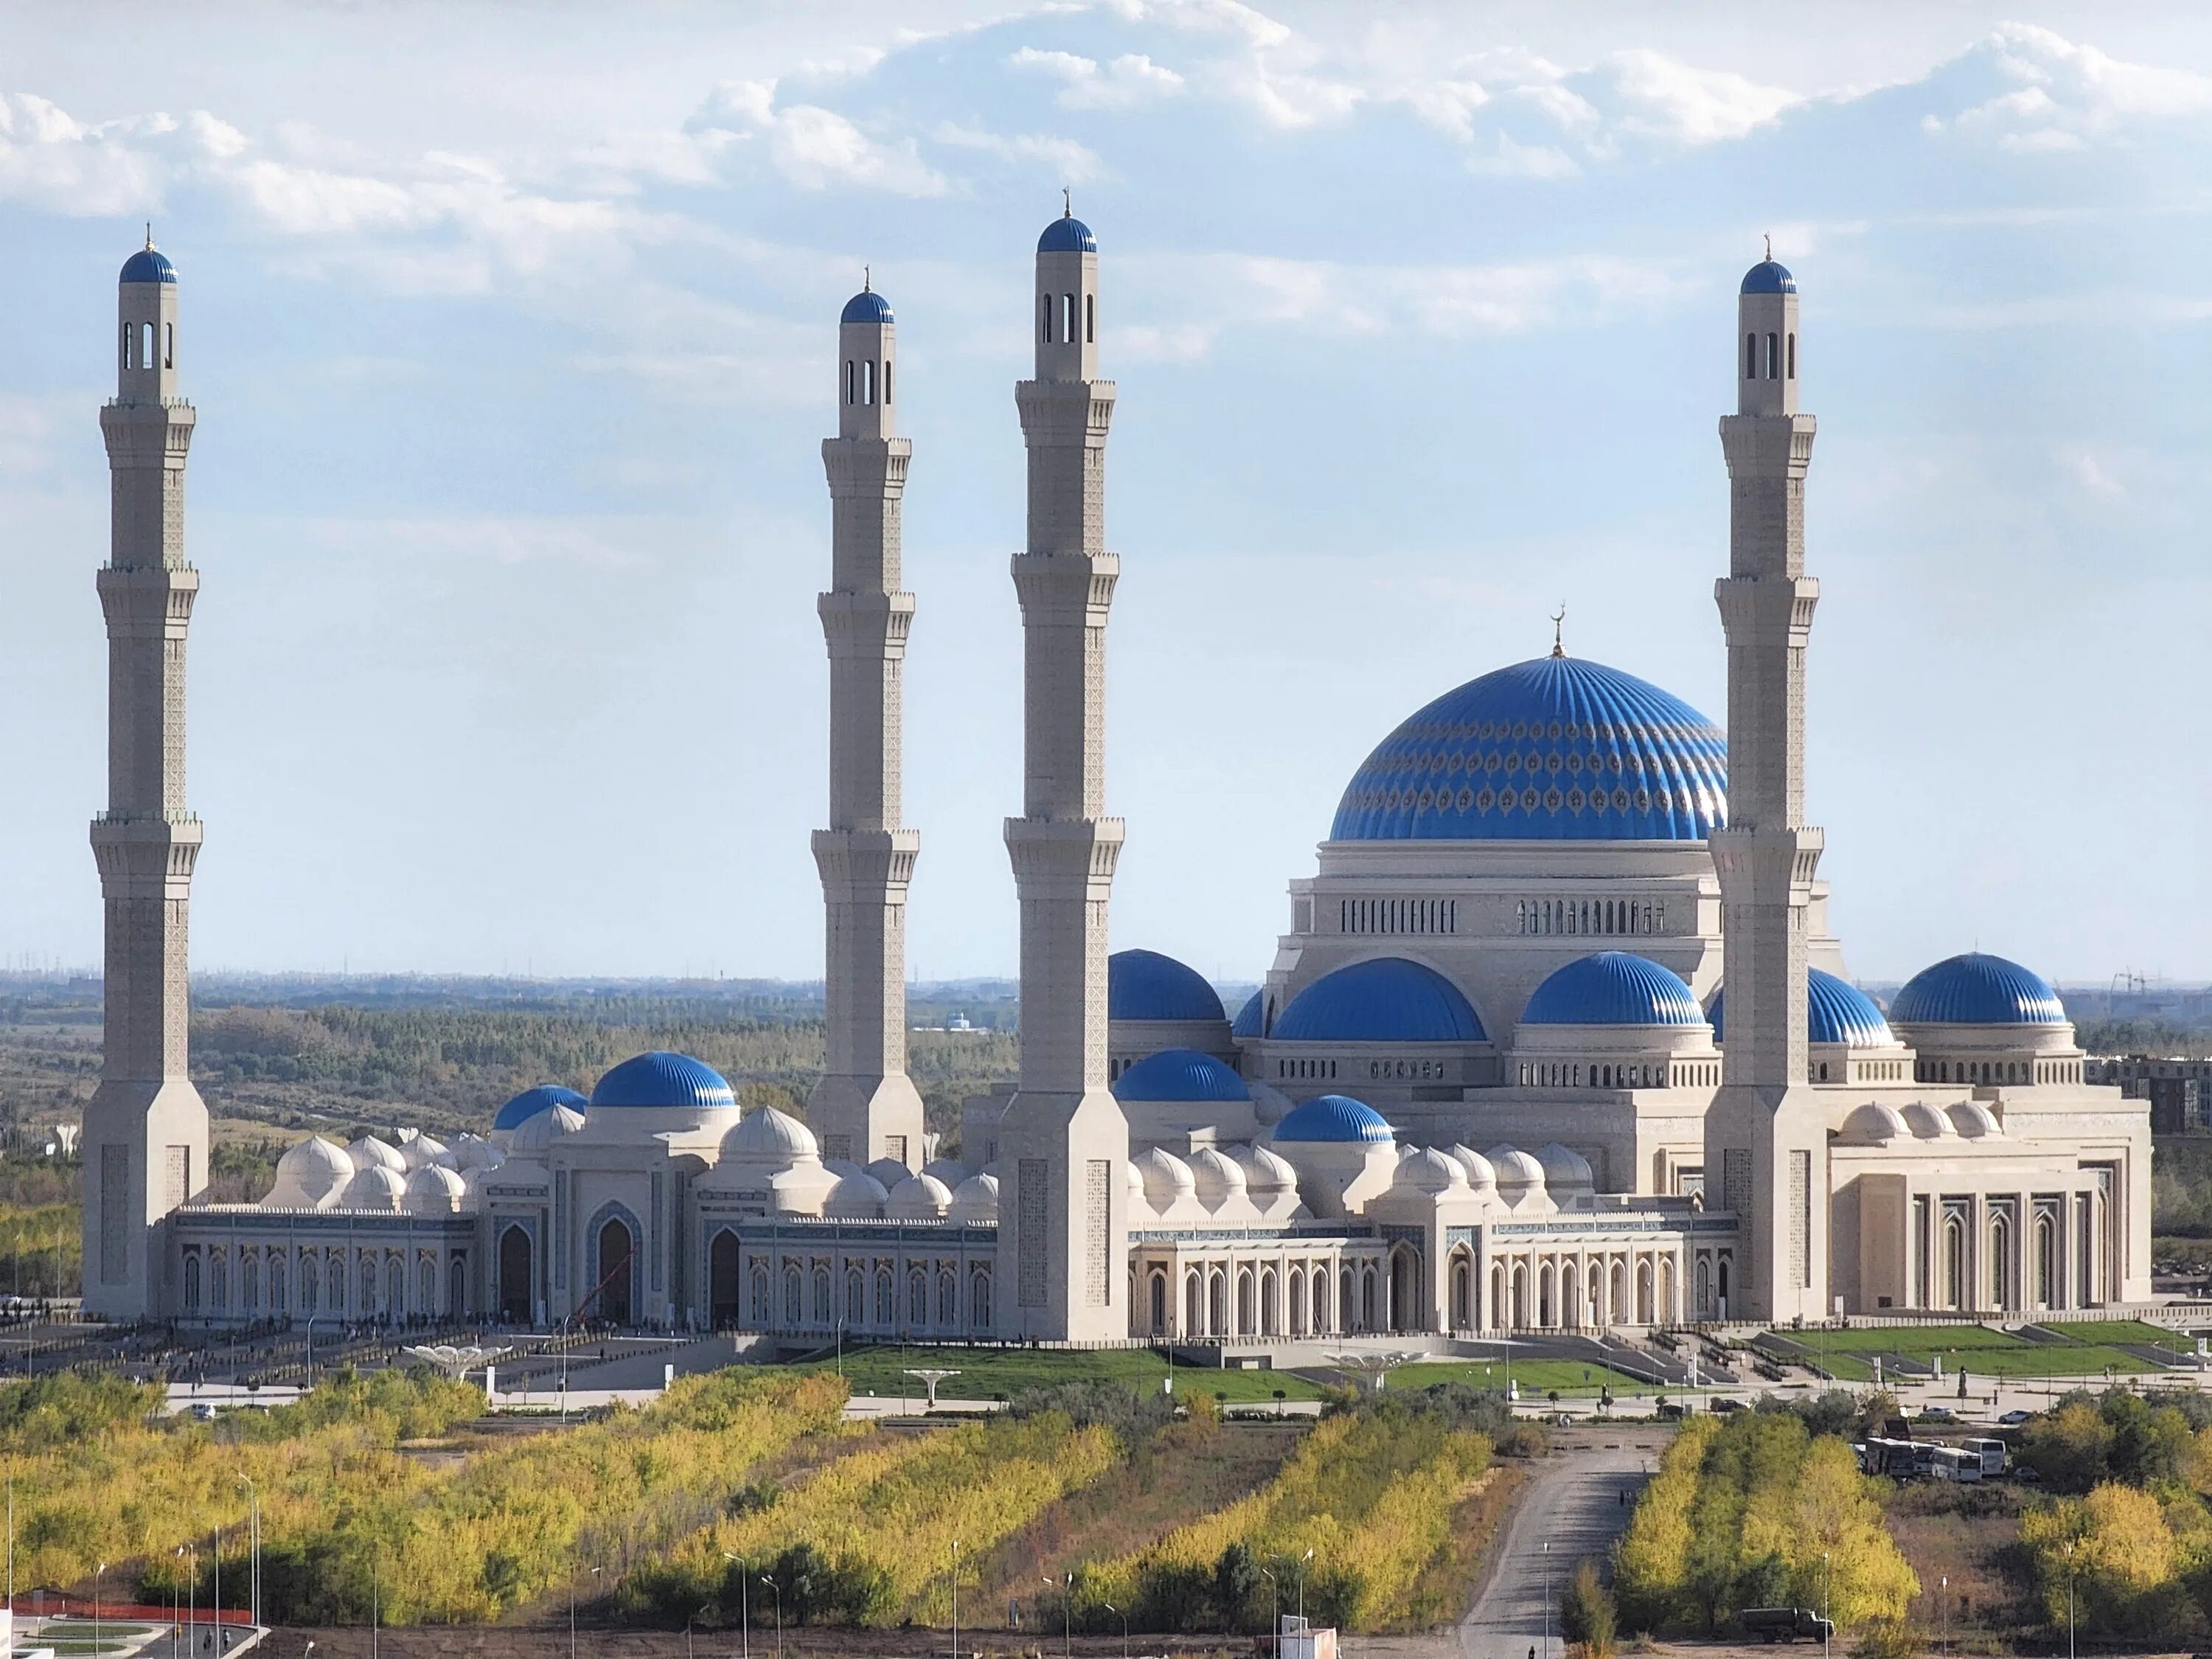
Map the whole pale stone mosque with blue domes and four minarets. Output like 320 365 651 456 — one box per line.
84 212 2150 1345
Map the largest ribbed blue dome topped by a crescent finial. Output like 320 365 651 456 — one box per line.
1329 657 1728 841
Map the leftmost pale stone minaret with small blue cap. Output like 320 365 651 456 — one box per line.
82 237 208 1318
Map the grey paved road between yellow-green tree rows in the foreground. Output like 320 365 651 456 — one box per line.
1458 1429 1666 1659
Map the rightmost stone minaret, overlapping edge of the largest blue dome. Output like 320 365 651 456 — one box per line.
1705 257 1829 1318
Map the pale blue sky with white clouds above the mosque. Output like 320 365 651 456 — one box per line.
0 0 2212 982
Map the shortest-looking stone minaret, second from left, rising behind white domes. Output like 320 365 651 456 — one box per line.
807 288 922 1170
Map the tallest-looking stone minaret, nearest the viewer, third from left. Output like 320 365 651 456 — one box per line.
993 215 1128 1340
